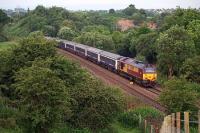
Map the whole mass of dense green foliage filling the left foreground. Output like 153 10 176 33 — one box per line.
0 32 124 132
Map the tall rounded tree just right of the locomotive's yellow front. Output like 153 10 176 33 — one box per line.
157 26 195 78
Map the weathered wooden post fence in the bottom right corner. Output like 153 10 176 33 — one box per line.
143 111 200 133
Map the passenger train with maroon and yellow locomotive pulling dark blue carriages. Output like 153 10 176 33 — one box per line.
51 39 157 88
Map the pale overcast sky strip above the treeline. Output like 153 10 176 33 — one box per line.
0 0 200 10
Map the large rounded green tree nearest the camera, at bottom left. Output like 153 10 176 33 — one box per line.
13 65 70 133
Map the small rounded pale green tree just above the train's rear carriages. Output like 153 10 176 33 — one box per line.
58 27 76 41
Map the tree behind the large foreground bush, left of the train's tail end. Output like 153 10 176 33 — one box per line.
11 32 56 71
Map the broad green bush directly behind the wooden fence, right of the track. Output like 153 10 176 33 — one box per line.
159 79 200 113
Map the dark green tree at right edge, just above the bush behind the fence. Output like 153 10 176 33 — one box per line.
181 56 200 83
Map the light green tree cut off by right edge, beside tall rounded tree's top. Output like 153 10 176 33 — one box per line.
187 20 200 55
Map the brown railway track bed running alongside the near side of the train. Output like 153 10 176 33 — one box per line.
57 49 166 112
